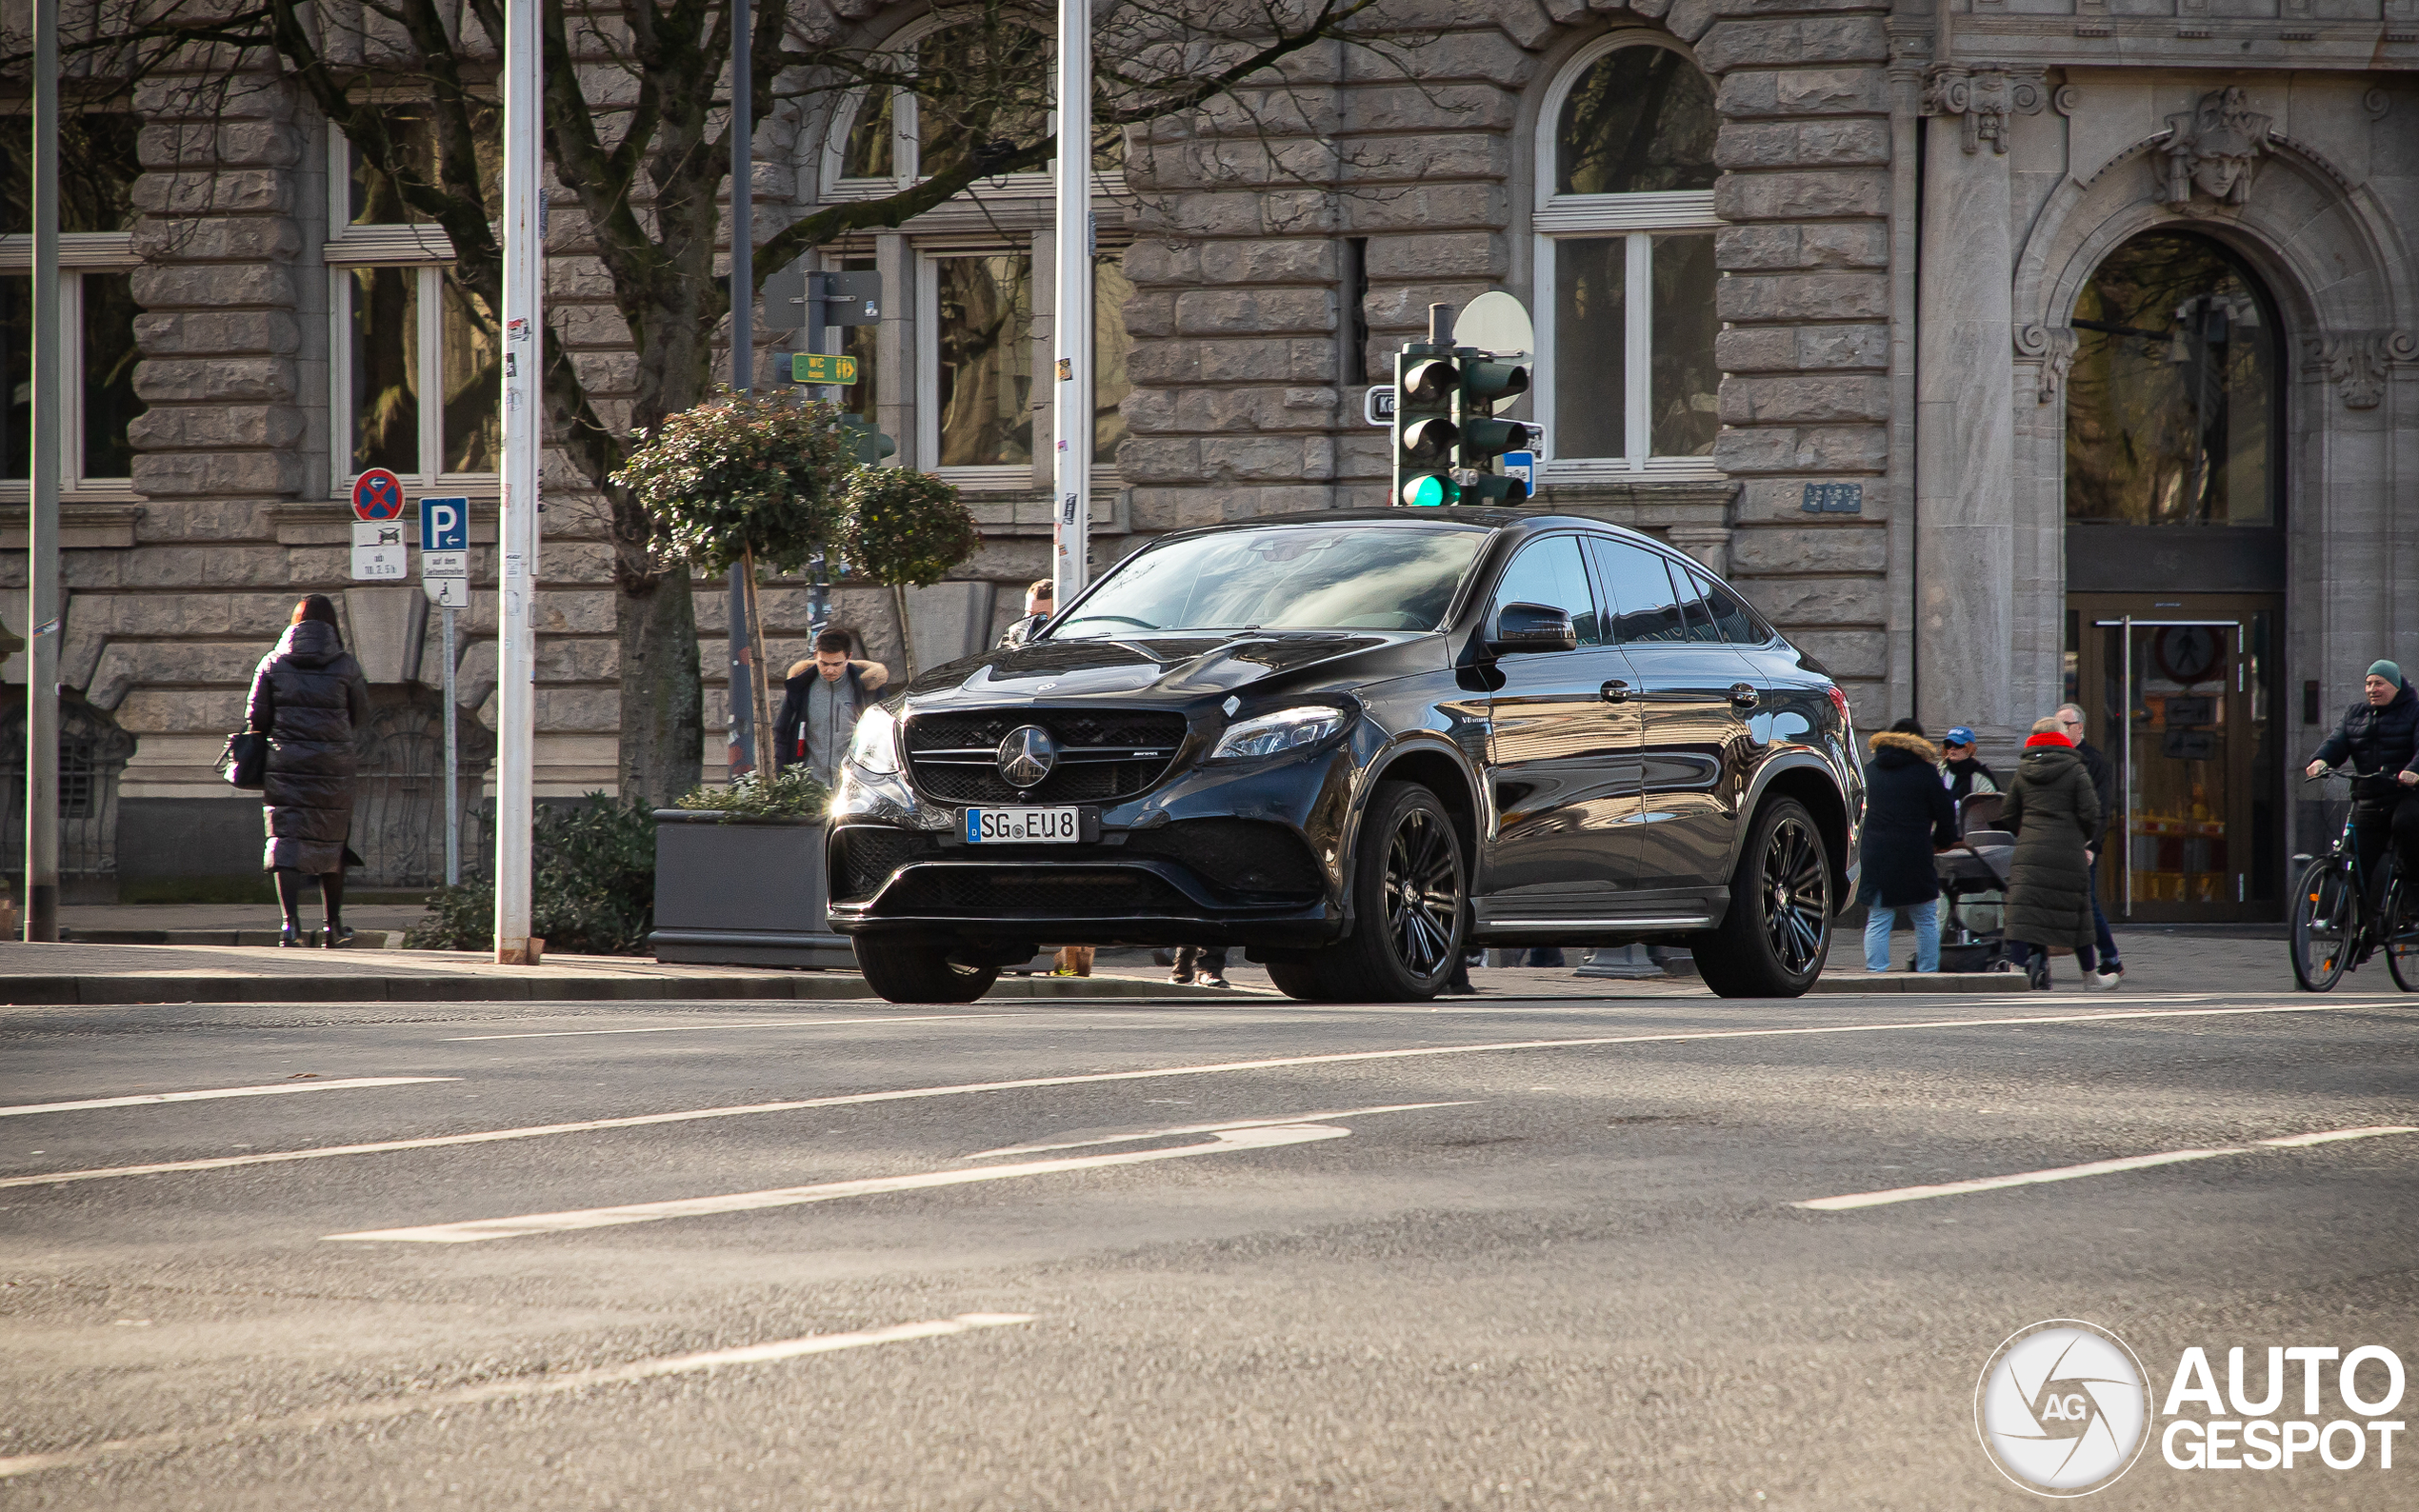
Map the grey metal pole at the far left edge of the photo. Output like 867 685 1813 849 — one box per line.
24 0 68 941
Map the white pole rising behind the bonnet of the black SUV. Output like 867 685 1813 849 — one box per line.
1050 0 1093 607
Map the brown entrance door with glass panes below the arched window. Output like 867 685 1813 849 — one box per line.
2069 592 2284 925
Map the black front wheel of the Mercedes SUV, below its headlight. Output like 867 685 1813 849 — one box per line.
1268 782 1470 1002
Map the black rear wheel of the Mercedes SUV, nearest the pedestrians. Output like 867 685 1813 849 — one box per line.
1696 798 1831 997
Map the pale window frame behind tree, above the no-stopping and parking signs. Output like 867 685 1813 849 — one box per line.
322 123 503 498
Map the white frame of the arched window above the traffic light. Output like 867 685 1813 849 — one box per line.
1529 29 1728 484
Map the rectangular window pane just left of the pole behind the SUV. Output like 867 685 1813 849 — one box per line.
922 251 1033 467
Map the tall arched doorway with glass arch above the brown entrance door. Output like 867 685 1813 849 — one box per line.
2066 229 2286 922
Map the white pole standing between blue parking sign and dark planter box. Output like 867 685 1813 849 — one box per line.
496 0 547 965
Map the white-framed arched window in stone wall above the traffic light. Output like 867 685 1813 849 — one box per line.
1533 31 1722 479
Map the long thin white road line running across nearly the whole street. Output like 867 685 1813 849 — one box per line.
0 1002 2369 1190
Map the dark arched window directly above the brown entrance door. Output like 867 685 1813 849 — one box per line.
2066 232 2284 527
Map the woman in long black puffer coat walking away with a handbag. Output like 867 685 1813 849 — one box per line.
247 592 370 948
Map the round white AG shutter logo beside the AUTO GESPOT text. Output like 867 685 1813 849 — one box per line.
1974 1319 2150 1498
